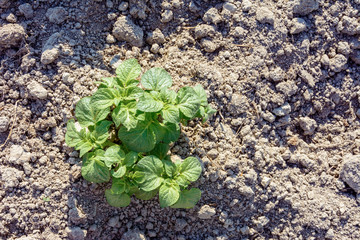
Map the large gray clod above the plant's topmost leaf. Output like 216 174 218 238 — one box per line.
113 16 144 47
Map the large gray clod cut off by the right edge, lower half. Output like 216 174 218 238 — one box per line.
340 154 360 193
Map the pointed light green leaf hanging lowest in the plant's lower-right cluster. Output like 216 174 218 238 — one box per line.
159 179 180 207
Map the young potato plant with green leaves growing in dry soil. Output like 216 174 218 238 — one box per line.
65 59 215 208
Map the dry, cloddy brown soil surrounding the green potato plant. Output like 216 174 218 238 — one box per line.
0 0 360 240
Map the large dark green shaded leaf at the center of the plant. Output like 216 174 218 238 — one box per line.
118 117 162 152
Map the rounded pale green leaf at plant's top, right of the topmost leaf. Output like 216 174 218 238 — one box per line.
141 68 172 91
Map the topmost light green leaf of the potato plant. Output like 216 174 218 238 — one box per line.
116 58 141 87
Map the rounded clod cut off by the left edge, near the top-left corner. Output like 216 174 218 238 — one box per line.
0 24 26 49
